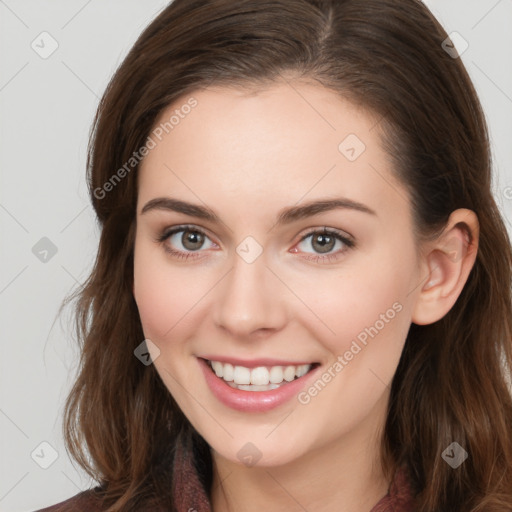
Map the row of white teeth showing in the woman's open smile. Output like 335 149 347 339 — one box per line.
210 361 312 391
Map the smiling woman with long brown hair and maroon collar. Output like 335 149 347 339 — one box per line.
36 0 512 512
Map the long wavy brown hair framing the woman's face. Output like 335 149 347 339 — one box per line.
59 0 512 512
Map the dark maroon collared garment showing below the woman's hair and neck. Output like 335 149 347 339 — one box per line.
37 442 414 512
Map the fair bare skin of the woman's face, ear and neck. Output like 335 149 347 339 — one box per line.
133 82 478 512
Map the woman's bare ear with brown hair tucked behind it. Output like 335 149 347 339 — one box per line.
412 209 480 325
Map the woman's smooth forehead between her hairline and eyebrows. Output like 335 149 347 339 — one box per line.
139 82 407 222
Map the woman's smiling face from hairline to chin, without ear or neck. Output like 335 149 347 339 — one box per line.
133 82 426 466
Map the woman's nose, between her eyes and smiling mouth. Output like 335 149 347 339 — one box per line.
213 248 287 341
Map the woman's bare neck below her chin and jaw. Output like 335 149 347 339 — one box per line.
211 400 390 512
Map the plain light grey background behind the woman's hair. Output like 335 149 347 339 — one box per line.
0 0 512 512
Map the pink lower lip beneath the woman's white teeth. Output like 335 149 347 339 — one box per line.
198 358 319 412
